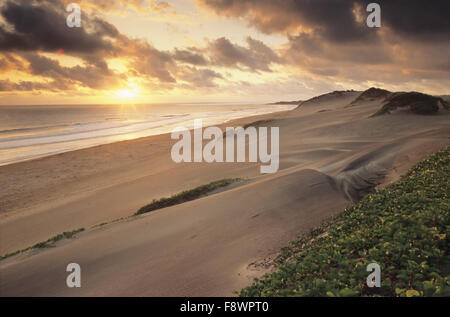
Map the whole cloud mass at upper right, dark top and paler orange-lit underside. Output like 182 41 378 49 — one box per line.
197 0 450 86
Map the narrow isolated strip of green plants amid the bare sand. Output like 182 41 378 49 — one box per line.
135 178 241 215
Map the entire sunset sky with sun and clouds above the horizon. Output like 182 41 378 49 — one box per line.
0 0 450 105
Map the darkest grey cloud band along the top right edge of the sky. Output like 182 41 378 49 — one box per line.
197 0 450 41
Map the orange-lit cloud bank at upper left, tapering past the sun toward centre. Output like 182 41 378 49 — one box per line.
0 1 246 91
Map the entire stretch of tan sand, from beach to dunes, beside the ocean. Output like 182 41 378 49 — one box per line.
0 90 450 296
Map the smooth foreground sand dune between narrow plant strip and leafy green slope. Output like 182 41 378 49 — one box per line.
1 170 347 296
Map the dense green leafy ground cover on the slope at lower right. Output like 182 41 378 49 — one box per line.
240 147 450 297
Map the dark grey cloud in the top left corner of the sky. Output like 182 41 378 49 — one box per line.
0 1 118 53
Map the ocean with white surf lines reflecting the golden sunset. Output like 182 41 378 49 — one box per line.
0 103 296 165
